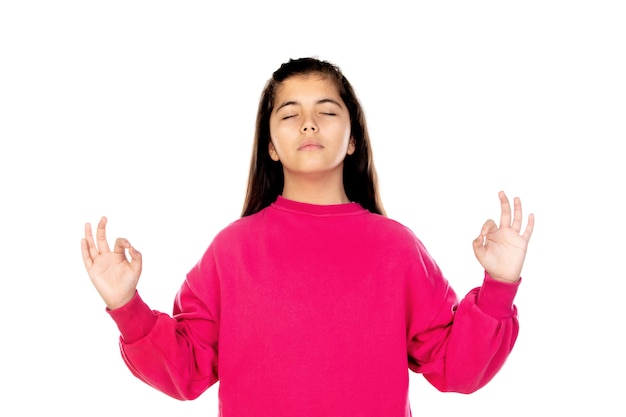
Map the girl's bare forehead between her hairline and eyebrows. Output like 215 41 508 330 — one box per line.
274 73 340 104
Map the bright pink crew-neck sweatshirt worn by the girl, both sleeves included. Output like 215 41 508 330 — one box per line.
109 197 519 417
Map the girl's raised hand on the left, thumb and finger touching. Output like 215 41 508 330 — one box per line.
81 217 141 310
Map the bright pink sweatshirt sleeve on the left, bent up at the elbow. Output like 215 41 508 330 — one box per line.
108 244 219 400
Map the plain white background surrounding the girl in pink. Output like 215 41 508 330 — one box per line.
0 0 626 417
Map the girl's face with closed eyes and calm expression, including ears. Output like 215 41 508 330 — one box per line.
269 74 355 181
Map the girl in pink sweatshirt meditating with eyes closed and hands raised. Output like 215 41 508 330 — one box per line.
81 58 534 417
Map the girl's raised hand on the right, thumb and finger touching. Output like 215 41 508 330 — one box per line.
473 191 535 282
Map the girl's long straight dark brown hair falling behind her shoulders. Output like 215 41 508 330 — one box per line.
242 58 385 217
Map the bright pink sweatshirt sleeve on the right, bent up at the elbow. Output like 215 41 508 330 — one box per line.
408 239 521 394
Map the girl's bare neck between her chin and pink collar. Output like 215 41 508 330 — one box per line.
282 172 350 205
